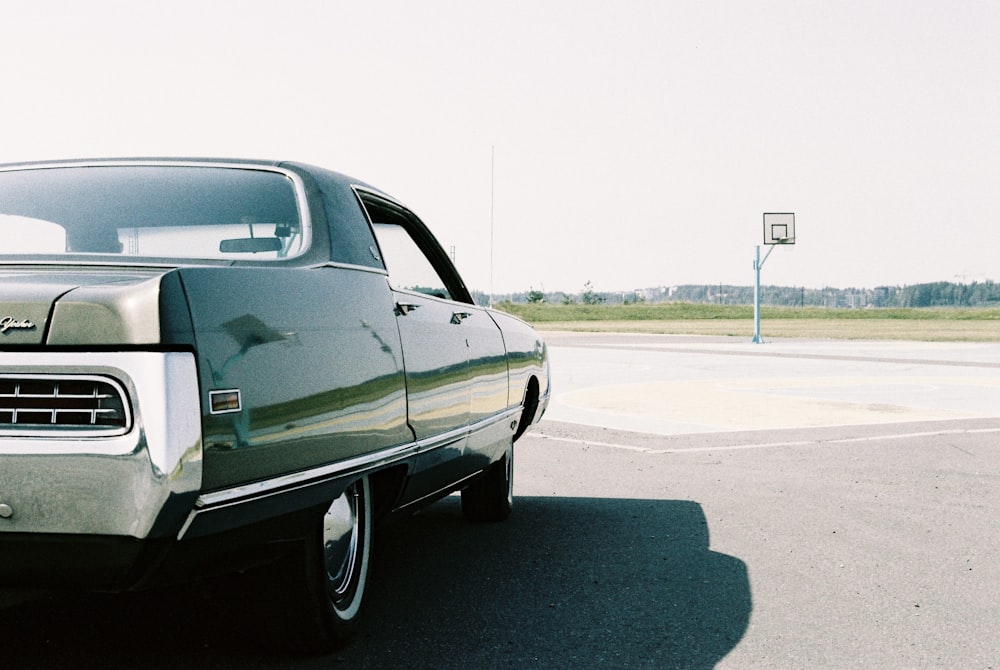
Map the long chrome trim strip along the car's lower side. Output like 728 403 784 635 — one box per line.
177 407 523 539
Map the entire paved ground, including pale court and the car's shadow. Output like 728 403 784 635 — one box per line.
0 334 1000 670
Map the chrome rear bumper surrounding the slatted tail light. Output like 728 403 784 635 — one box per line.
0 351 202 539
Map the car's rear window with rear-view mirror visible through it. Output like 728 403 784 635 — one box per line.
0 165 308 260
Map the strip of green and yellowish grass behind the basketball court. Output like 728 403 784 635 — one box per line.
497 303 1000 342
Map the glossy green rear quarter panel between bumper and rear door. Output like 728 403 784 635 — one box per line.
181 267 412 491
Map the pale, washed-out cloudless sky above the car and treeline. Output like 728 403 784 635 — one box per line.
0 0 1000 293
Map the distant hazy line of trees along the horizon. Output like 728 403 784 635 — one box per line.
476 281 1000 309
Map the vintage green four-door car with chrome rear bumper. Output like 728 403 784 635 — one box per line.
0 158 549 650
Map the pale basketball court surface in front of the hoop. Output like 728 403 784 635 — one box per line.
544 332 1000 435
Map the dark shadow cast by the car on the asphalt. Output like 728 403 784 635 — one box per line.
0 496 752 670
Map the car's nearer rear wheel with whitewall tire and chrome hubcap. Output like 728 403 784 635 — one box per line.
271 476 372 653
